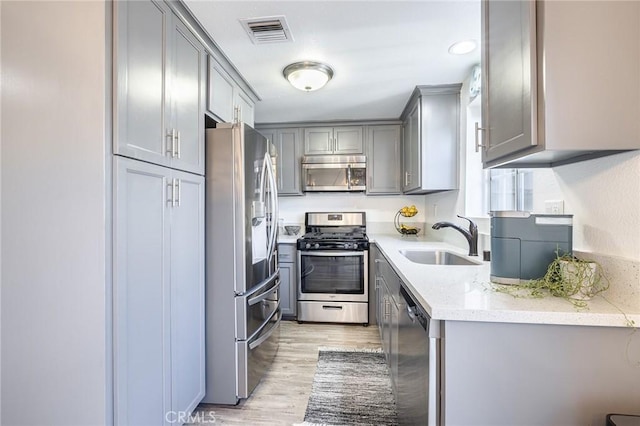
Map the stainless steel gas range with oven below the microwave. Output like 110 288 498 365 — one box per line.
297 212 369 325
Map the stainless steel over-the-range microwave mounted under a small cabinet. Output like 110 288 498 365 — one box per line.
302 155 367 192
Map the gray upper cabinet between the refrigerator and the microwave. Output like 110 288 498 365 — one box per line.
258 127 303 196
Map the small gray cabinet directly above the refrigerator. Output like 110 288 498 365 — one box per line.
207 55 254 127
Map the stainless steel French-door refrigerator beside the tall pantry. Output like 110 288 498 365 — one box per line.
203 124 282 404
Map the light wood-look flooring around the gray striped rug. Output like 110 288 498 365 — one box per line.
194 321 380 426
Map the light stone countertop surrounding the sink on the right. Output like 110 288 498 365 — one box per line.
368 234 640 327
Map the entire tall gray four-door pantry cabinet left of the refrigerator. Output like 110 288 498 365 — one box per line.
113 0 206 425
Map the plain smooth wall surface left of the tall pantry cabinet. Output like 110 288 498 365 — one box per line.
0 1 108 425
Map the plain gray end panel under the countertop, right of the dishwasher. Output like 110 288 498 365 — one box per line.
440 321 640 426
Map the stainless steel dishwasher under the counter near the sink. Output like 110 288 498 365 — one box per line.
397 287 440 425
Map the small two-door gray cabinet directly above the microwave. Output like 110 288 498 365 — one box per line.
304 126 364 155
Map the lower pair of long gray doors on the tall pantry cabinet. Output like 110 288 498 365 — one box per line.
113 156 205 426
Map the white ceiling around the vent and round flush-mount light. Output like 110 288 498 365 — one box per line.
186 0 480 123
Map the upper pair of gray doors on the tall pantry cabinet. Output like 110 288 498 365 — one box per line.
114 0 206 174
